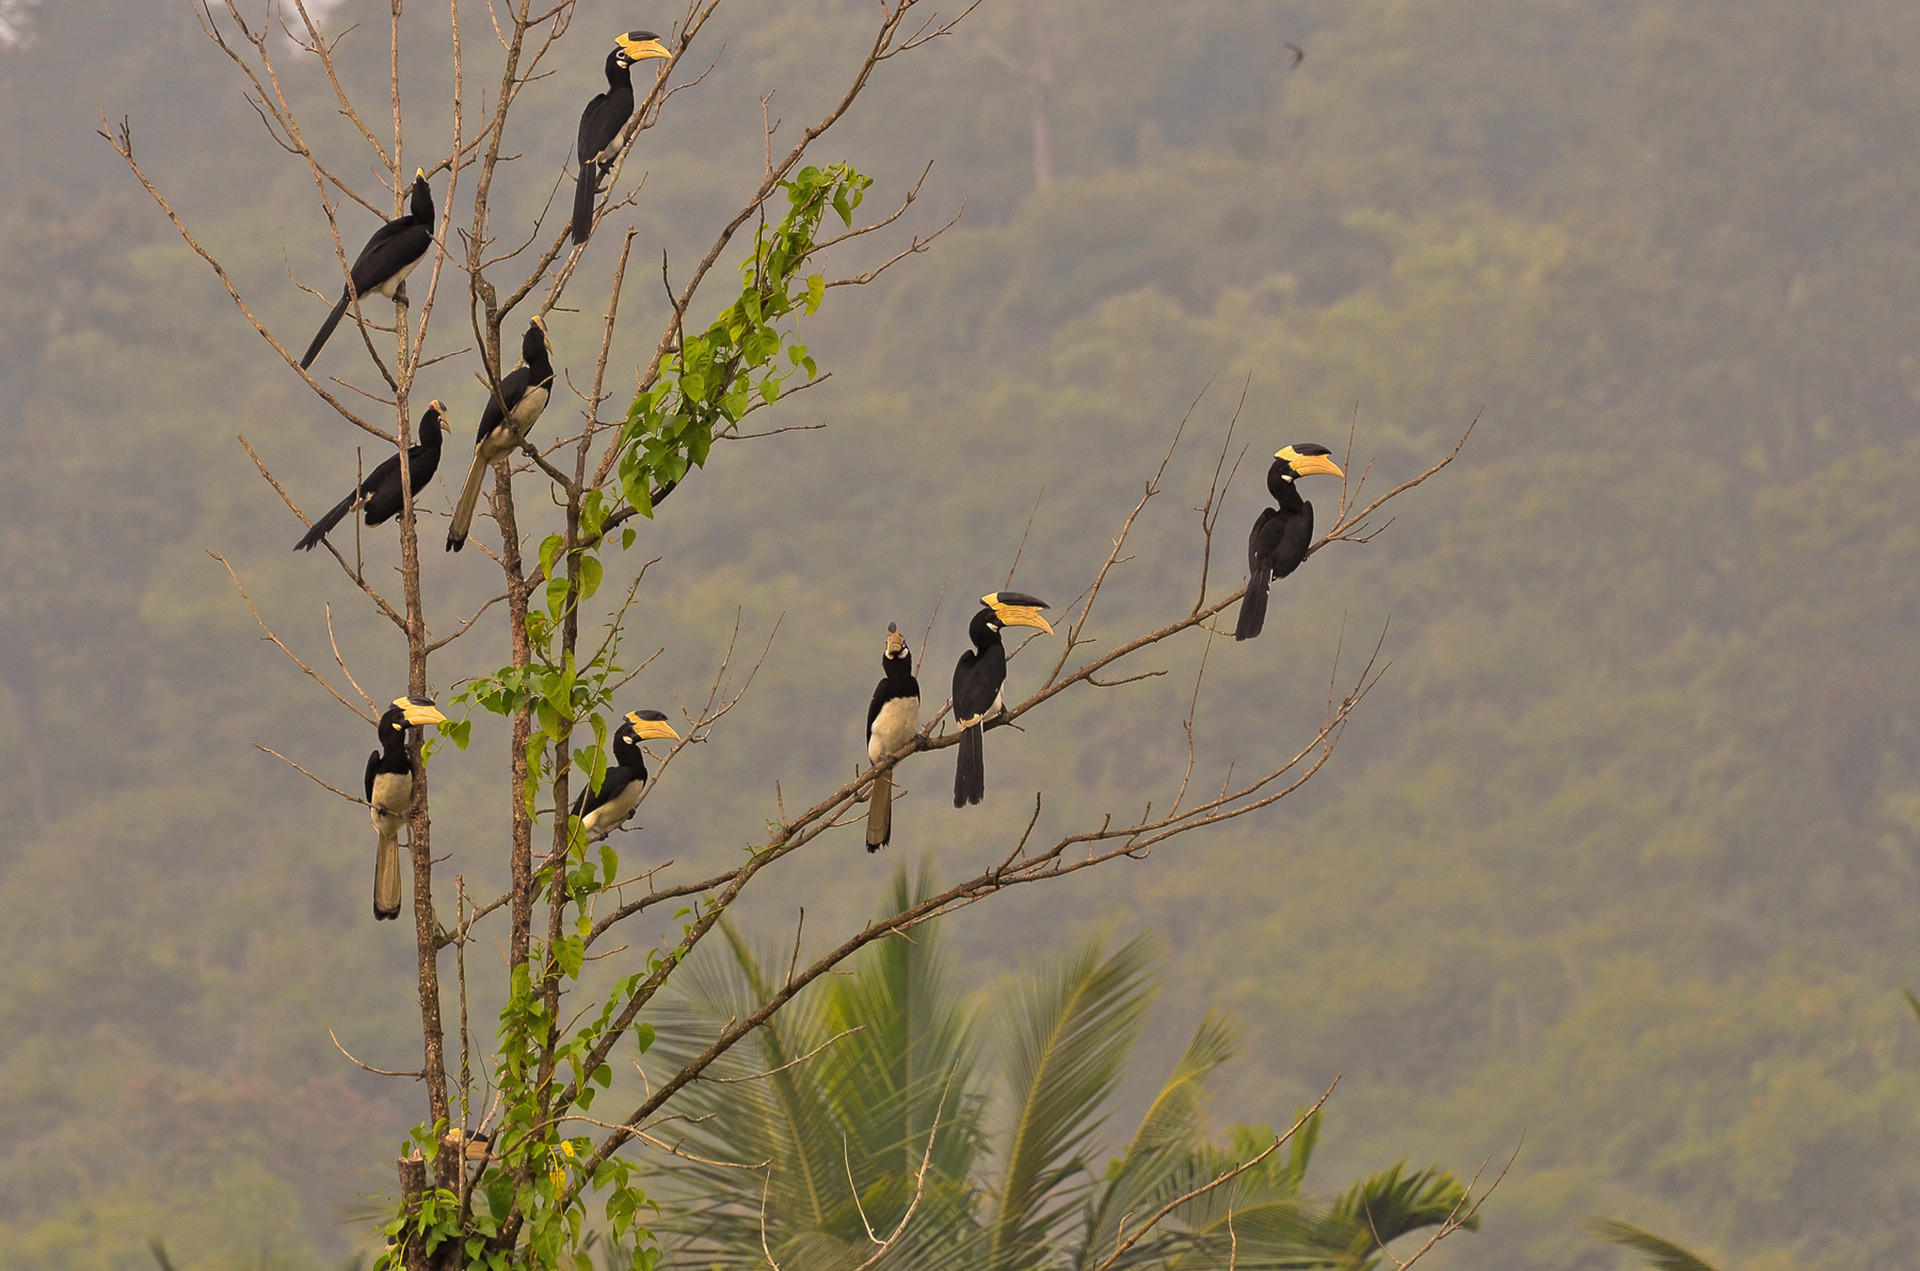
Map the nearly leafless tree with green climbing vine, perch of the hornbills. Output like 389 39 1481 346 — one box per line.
102 0 1465 1271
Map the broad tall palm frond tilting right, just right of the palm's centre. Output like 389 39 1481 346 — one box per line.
979 937 1158 1271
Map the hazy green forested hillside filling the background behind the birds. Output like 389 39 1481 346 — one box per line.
0 0 1920 1271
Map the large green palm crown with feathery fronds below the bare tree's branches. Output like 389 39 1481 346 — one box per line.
637 872 1476 1271
